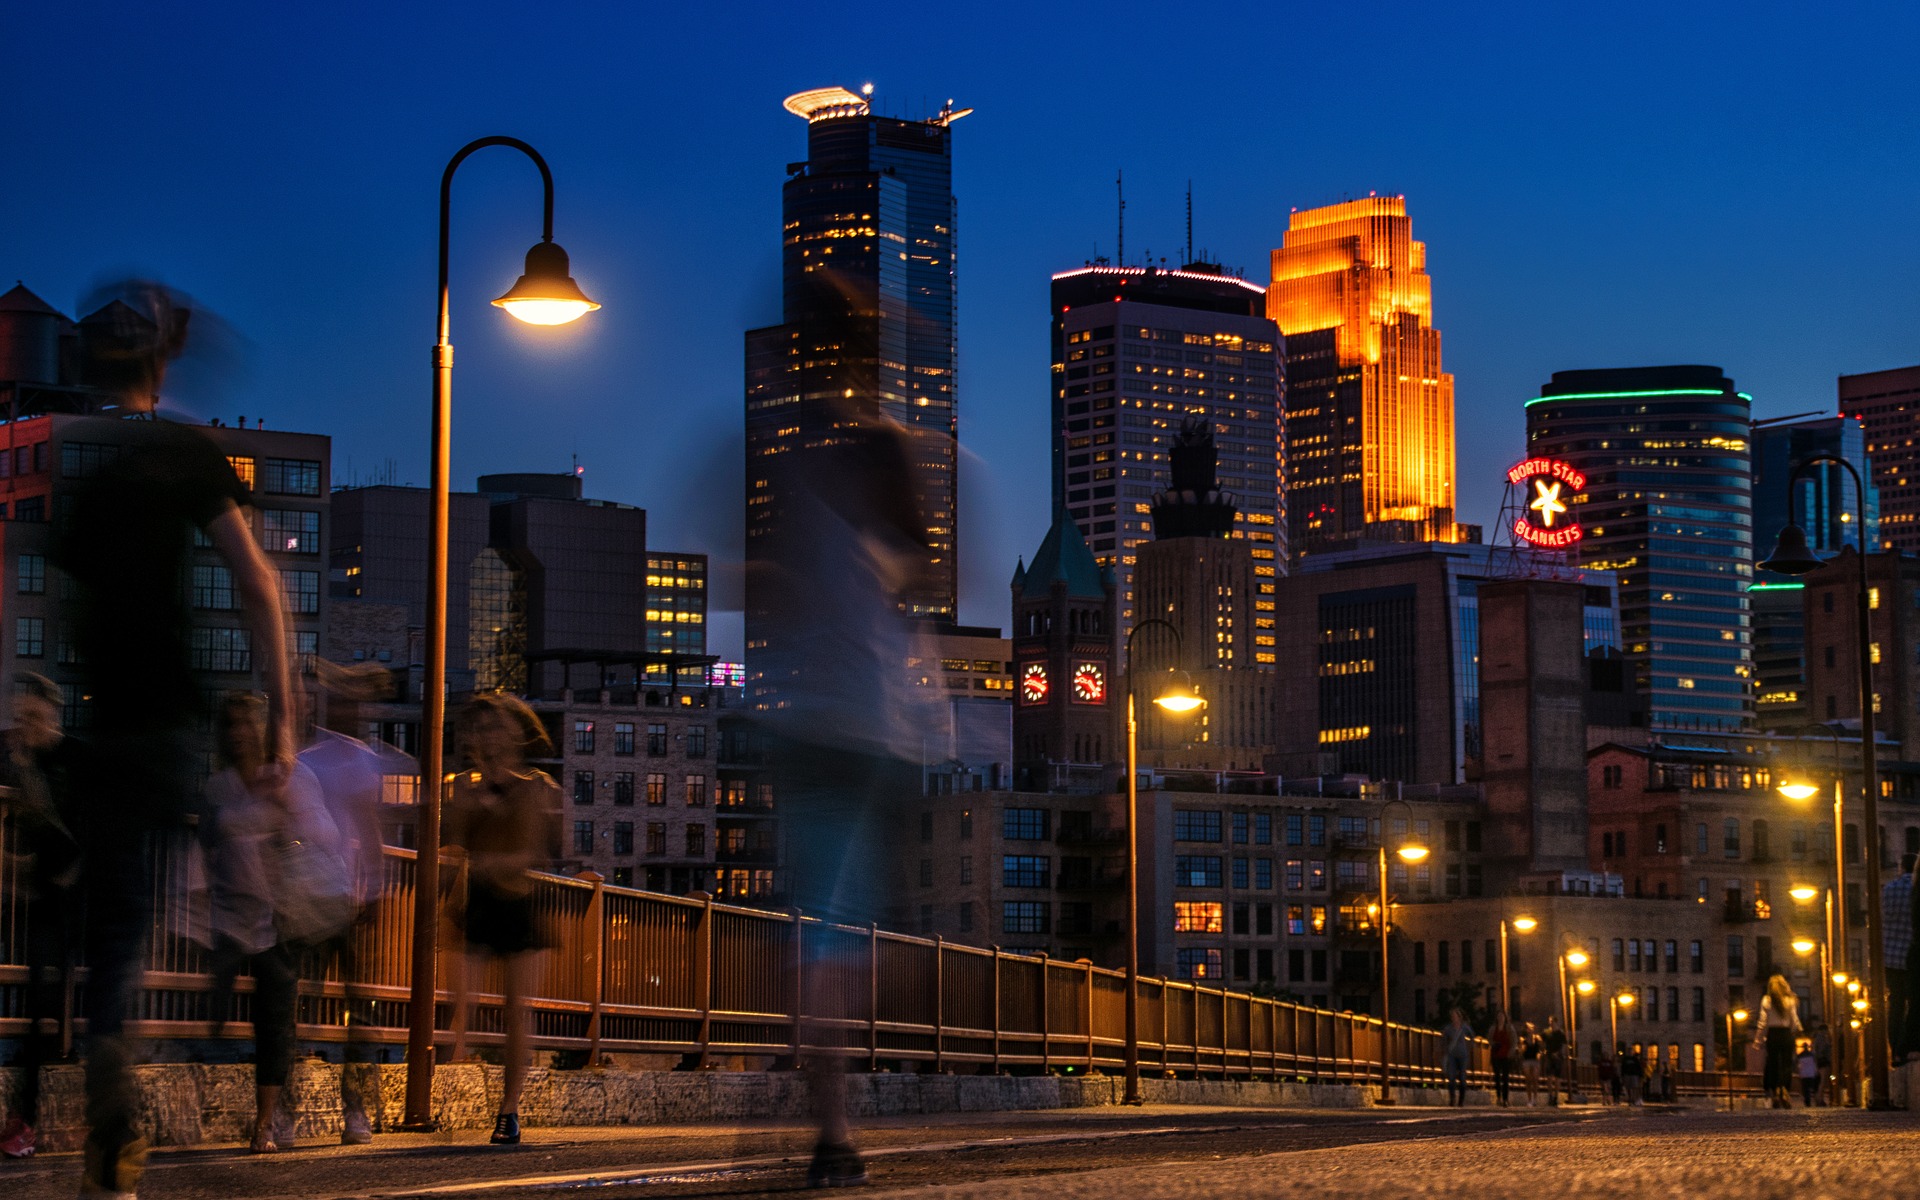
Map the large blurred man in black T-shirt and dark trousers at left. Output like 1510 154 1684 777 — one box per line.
50 284 294 1196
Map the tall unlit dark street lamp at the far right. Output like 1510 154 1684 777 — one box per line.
1761 455 1889 1108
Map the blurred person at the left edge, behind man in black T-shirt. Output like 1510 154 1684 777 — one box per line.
0 672 81 1158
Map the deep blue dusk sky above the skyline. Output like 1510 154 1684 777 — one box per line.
0 0 1920 655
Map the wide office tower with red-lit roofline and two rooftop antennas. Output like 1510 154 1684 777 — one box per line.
1050 263 1286 636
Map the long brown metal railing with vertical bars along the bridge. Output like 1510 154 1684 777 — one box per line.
0 828 1512 1085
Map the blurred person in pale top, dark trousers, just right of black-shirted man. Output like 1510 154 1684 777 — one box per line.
200 693 346 1154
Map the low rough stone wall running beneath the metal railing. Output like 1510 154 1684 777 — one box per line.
0 1060 1488 1150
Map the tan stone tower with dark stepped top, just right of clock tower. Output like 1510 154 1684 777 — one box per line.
1131 419 1275 772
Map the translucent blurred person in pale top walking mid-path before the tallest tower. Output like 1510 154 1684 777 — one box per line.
747 392 936 1187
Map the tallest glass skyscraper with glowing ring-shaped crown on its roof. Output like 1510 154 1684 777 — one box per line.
747 88 972 705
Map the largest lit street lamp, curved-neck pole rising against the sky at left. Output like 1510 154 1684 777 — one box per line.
401 138 599 1129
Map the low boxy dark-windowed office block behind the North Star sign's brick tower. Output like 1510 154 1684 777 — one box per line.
1275 543 1620 783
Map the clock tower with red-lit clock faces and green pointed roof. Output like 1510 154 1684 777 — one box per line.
1012 511 1123 791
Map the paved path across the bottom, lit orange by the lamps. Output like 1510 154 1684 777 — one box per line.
0 1106 1920 1200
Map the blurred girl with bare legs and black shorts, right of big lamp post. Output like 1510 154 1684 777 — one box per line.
442 693 561 1146
